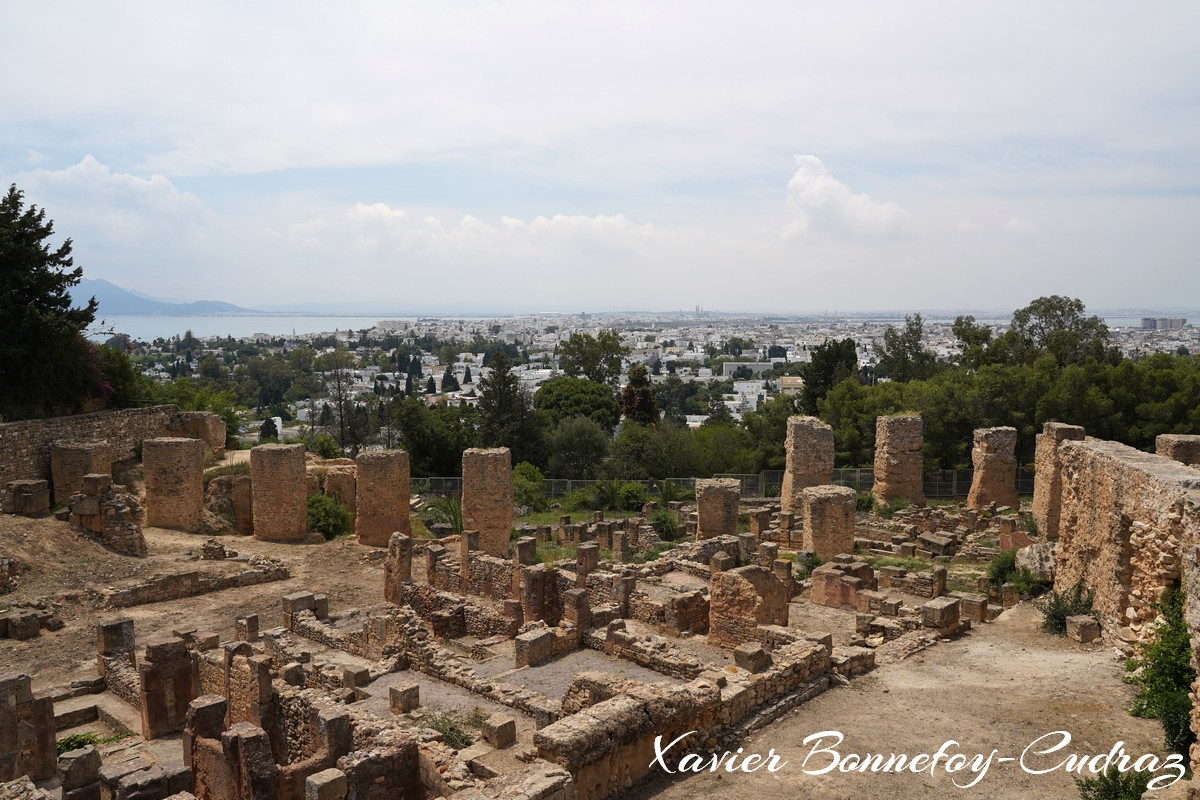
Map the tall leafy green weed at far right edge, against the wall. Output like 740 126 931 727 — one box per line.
1126 587 1196 757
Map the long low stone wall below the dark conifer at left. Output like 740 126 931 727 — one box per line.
0 405 224 498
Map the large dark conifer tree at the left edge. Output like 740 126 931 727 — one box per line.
0 185 103 419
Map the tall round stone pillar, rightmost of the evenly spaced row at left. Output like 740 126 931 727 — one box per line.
462 447 514 558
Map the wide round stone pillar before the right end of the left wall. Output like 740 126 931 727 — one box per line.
142 438 204 531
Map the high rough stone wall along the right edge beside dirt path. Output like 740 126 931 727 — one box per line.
1055 438 1200 650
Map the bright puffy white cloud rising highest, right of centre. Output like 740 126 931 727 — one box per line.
785 155 908 237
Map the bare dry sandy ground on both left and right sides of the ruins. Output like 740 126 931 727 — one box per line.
0 516 1180 800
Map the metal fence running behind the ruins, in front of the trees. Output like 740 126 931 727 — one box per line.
412 467 1033 499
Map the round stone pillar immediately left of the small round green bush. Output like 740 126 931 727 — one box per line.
250 445 308 542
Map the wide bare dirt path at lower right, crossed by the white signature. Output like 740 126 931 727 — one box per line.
630 604 1180 800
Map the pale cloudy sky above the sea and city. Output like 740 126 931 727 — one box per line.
0 0 1200 313
